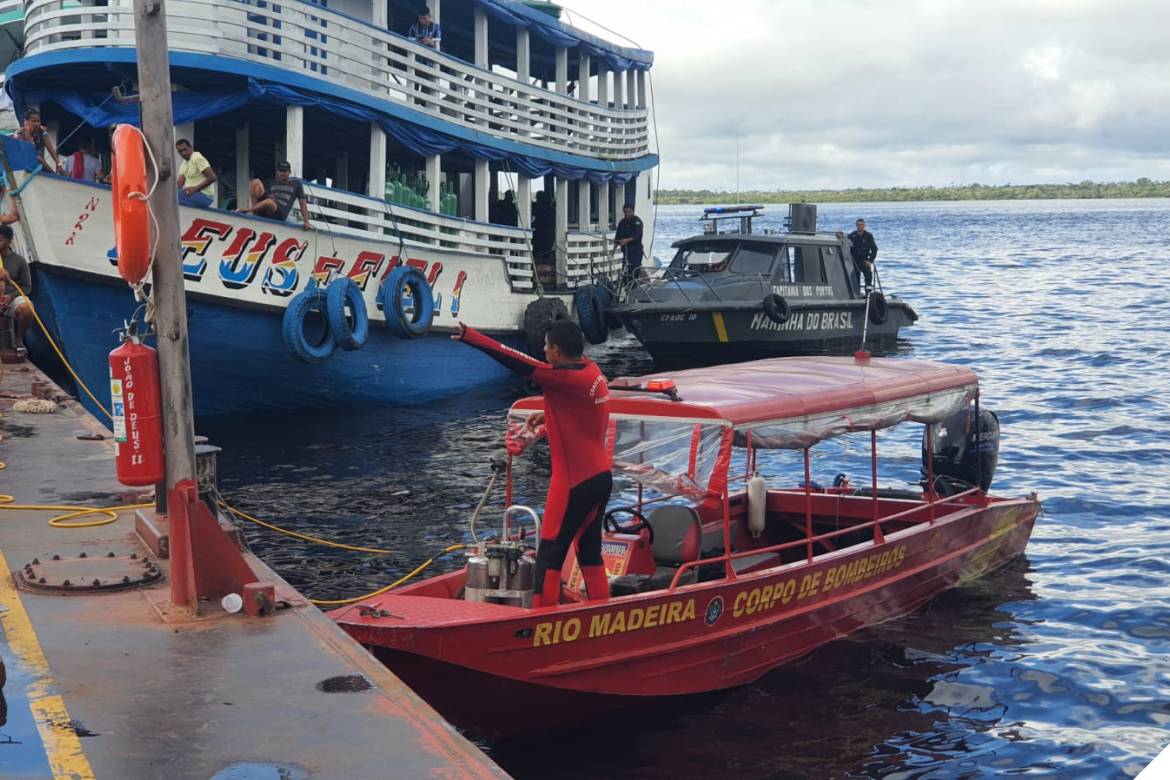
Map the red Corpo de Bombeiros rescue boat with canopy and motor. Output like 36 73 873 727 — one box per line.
331 356 1040 734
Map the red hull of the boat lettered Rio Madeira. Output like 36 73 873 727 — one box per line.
332 498 1039 734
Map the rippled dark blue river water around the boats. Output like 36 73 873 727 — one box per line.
199 200 1170 778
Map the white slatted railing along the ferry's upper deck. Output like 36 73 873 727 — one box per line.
25 0 649 160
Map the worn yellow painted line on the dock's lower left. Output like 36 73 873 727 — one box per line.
0 552 95 780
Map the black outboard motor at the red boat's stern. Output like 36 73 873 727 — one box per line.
922 405 999 496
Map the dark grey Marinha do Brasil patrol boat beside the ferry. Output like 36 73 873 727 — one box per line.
589 203 918 364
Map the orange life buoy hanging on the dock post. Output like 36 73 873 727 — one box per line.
111 125 151 284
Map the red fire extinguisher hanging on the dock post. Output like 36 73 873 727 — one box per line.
110 327 164 485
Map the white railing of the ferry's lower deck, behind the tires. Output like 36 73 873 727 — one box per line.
304 182 621 292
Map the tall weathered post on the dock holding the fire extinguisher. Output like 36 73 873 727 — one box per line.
135 0 197 607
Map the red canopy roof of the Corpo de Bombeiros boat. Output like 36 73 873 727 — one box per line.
512 357 978 449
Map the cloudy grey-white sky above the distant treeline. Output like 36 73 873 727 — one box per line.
563 0 1170 189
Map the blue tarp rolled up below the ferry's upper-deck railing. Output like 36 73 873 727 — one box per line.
21 78 656 185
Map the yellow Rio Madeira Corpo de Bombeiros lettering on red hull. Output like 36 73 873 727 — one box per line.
531 545 906 648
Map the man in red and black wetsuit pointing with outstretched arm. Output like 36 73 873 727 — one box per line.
452 319 613 607
